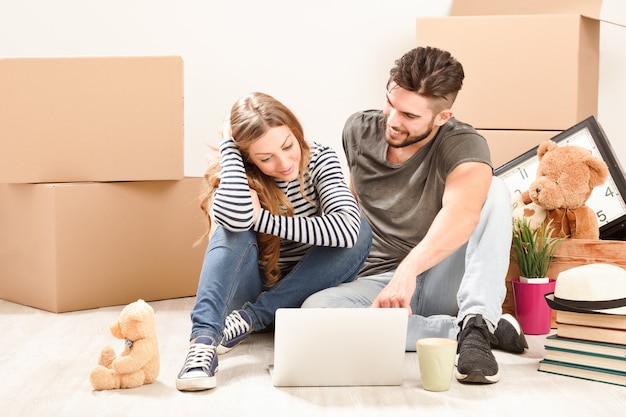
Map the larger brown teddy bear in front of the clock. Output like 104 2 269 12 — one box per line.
513 140 609 239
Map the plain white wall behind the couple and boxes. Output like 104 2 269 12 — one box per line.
0 0 626 176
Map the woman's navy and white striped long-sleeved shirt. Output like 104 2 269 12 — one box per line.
212 139 360 270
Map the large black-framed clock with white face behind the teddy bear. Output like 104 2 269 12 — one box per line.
494 116 626 239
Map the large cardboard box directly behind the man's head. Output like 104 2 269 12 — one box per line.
416 14 600 130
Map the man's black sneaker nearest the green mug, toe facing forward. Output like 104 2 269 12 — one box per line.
454 314 500 384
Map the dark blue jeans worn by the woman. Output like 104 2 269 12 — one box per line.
191 219 372 343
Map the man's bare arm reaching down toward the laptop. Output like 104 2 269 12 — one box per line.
372 162 492 313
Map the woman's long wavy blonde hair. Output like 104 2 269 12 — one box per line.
200 92 311 288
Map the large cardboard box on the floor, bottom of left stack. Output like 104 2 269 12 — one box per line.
0 178 205 312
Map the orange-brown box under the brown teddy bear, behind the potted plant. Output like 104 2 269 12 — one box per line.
502 239 626 327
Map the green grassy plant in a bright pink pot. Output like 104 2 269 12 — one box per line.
511 218 563 334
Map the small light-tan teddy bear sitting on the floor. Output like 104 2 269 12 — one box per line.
89 299 160 391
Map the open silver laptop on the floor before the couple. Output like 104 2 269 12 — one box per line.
270 308 408 387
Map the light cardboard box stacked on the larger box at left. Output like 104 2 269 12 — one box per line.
0 57 184 183
